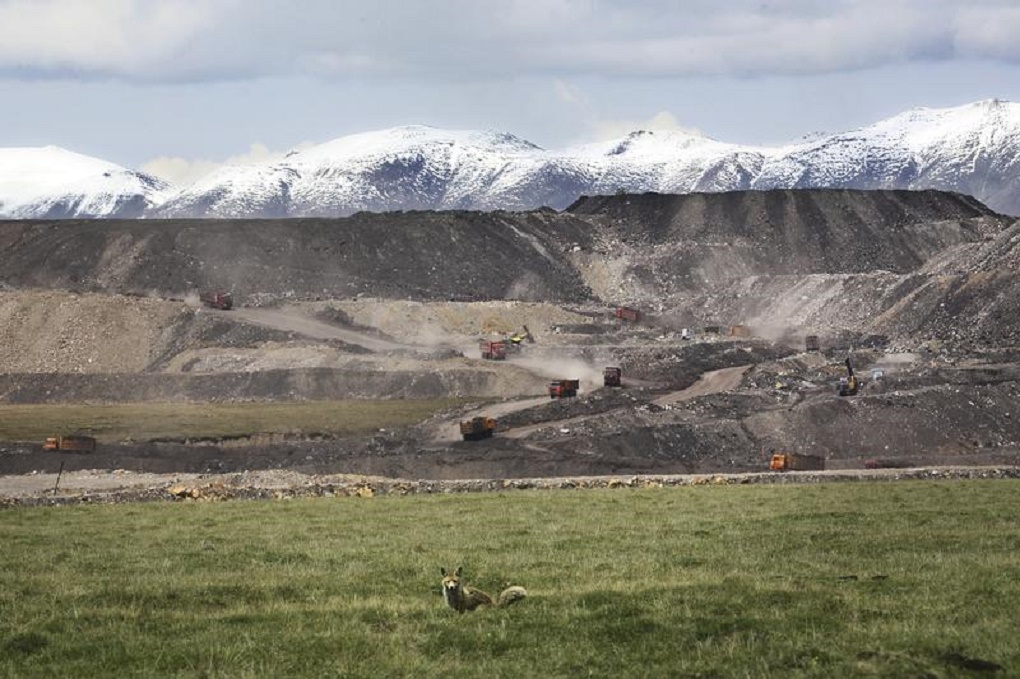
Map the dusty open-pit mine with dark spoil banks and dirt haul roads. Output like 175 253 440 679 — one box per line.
0 190 1020 499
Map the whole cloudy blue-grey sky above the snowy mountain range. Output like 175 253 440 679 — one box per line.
0 0 1020 181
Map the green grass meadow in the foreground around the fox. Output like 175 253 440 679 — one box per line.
0 480 1020 677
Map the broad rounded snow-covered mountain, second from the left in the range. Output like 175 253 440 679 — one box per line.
150 126 545 217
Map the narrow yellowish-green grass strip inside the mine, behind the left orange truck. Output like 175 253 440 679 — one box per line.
0 399 463 442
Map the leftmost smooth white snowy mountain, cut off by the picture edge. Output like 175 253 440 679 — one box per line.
0 146 170 219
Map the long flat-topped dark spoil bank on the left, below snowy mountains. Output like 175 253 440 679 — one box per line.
0 212 590 304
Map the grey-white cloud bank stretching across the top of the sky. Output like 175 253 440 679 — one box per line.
0 0 1020 82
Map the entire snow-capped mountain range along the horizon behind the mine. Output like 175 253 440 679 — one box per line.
0 100 1020 218
